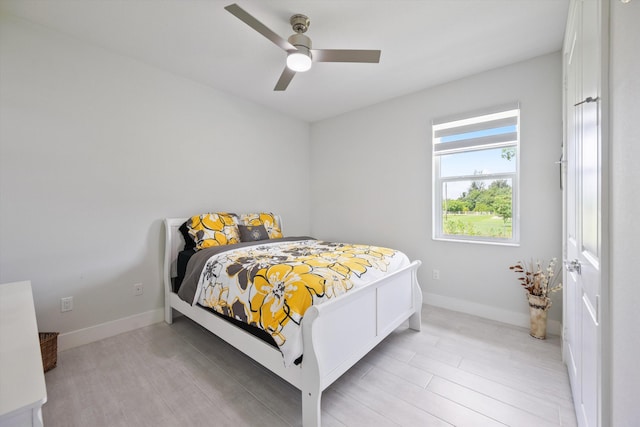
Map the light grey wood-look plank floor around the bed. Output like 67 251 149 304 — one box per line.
43 306 576 427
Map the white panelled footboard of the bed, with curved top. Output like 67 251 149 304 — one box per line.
302 261 422 427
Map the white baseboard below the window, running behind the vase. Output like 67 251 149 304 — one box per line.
423 292 562 336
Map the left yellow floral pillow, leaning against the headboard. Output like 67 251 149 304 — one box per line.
187 212 240 250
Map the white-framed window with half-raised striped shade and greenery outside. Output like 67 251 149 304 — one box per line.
432 104 520 244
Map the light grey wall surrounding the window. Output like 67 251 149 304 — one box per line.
311 53 562 333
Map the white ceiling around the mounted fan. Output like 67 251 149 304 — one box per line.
0 0 569 122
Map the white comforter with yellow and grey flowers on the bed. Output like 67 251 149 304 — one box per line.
180 239 409 366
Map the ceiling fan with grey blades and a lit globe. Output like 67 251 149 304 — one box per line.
225 3 380 91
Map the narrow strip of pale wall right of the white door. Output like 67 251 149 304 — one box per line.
604 1 640 427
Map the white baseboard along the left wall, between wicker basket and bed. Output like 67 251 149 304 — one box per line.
58 308 164 351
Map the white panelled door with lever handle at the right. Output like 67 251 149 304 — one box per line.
564 0 602 426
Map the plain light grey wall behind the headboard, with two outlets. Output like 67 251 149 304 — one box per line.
0 16 310 342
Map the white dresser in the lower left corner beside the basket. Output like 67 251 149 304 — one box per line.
0 281 47 427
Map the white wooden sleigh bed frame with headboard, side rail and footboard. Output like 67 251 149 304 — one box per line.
164 218 422 427
